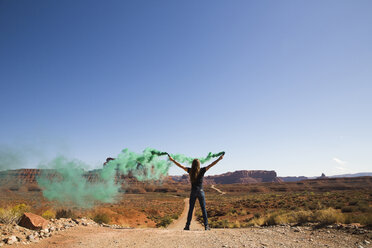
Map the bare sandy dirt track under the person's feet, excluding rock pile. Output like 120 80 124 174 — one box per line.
15 199 372 248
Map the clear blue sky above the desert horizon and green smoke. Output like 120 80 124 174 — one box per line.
0 0 372 176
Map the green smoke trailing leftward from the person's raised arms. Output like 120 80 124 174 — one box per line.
37 148 224 207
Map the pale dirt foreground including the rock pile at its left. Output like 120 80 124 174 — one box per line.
0 199 372 248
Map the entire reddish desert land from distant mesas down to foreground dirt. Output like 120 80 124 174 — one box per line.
0 169 372 247
